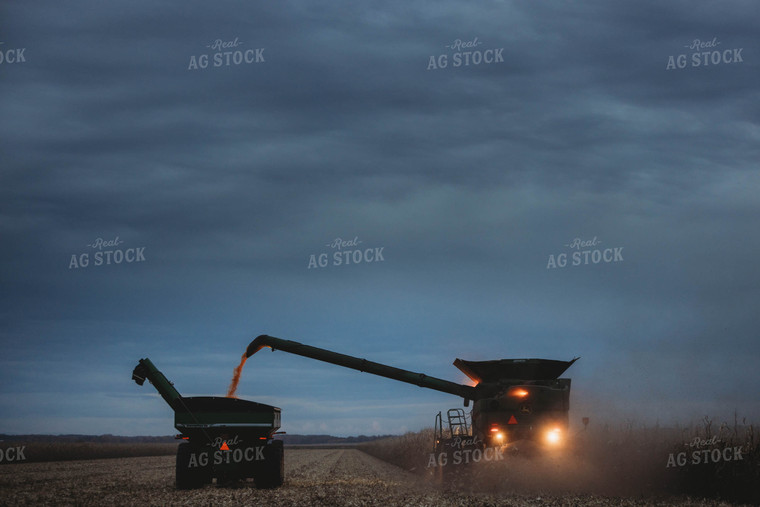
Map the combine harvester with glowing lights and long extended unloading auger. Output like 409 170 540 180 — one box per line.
246 335 579 461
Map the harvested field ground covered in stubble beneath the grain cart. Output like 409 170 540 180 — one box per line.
0 448 740 507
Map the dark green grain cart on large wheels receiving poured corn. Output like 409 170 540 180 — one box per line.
132 358 284 489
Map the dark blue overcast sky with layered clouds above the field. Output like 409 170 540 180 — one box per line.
0 0 760 435
